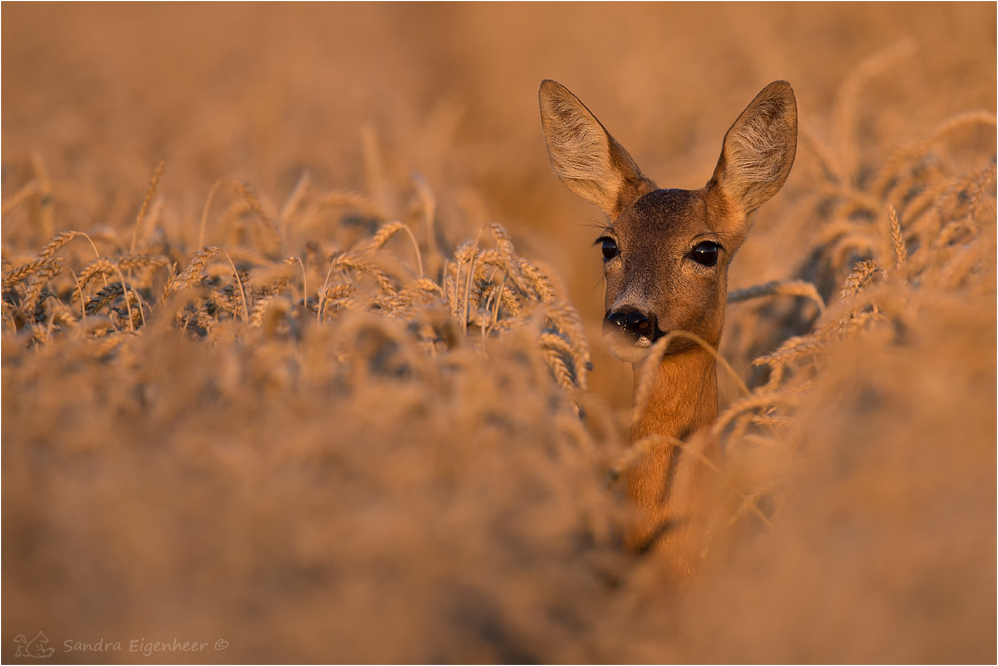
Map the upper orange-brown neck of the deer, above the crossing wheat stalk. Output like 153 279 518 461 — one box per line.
631 348 717 442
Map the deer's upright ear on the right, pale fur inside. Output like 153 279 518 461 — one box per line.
707 81 797 216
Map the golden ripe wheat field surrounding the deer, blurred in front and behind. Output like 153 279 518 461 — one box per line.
0 3 998 663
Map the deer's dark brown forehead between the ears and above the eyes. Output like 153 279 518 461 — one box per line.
613 190 713 243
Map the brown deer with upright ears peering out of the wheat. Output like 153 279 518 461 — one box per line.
538 80 797 581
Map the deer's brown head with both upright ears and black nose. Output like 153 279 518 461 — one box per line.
540 80 797 363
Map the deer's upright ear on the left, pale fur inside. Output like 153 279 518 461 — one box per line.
538 80 656 219
